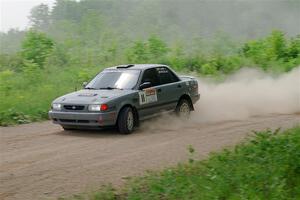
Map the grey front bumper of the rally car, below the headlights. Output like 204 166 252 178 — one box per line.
48 110 117 127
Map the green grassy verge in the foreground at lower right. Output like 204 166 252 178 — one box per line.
59 126 300 200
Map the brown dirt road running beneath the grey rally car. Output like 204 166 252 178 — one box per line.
0 115 300 200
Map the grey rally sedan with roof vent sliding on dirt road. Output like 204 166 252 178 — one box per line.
49 64 200 134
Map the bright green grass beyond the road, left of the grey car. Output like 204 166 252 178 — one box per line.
0 66 101 126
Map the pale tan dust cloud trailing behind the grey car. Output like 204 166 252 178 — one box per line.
141 66 300 132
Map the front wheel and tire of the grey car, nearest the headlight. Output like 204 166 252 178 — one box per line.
117 107 136 134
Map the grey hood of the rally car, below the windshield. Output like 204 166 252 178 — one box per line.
54 90 134 104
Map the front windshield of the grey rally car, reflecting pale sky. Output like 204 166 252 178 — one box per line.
85 70 140 90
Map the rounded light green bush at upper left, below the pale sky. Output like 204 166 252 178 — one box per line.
21 30 54 68
